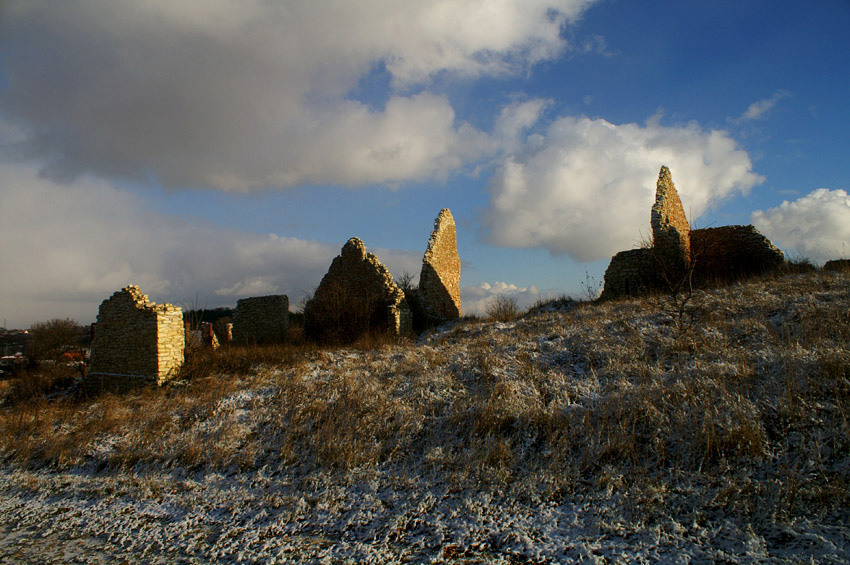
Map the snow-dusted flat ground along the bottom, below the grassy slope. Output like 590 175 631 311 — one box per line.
0 462 850 563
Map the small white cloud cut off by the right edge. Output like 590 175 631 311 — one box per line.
750 188 850 261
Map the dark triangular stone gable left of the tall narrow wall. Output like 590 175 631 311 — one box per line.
304 238 412 343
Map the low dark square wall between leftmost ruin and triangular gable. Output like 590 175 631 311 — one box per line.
232 294 289 344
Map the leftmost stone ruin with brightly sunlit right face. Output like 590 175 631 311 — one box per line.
85 285 185 392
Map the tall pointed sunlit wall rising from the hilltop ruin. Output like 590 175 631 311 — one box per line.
650 167 691 278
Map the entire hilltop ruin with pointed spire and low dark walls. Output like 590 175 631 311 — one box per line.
602 167 785 299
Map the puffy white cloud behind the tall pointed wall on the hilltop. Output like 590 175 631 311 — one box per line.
484 117 762 261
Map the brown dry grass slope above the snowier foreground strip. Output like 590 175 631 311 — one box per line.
0 273 850 516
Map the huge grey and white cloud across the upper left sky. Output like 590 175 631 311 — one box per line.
0 0 592 191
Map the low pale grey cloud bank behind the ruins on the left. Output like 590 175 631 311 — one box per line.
0 163 416 327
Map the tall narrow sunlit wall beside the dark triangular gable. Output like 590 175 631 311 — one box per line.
419 208 461 320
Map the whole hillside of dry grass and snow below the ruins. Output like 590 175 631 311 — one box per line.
0 272 850 563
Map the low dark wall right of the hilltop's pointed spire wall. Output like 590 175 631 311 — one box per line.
691 225 785 284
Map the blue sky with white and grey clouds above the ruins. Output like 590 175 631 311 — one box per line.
0 0 850 328
